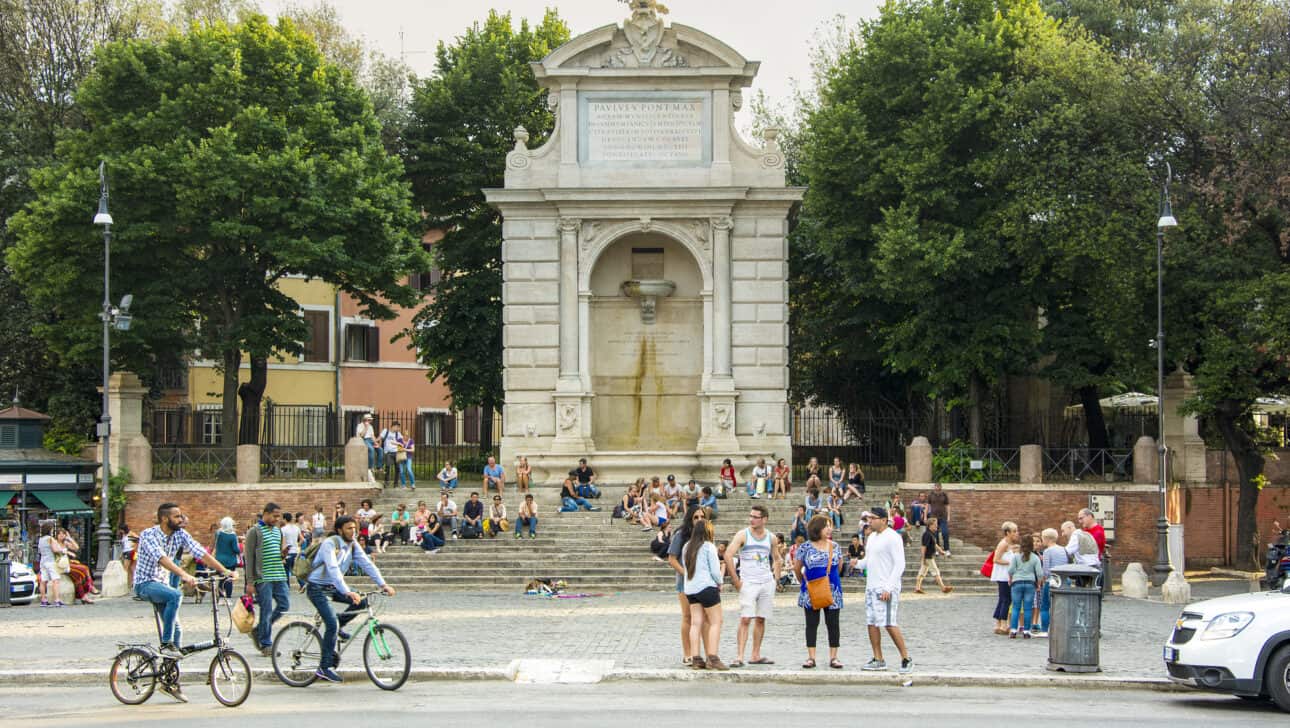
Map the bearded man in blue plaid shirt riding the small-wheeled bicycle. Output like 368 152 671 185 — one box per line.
134 503 232 702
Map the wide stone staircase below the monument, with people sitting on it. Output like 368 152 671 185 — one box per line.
363 485 995 594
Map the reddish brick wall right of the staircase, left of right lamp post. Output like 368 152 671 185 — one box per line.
900 483 1160 569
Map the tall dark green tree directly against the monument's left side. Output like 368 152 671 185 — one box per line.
405 10 569 448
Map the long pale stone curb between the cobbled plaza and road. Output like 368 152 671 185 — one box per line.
0 663 1187 692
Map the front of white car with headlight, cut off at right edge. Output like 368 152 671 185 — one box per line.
1165 587 1290 713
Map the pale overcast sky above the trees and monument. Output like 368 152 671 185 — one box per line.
262 0 878 118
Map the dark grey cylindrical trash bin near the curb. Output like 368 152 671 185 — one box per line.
1047 564 1102 672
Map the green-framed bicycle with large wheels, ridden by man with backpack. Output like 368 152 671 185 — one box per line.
273 590 412 691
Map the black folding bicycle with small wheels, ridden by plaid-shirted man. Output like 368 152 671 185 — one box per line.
108 574 252 707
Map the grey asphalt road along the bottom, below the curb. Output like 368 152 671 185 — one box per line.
0 682 1286 728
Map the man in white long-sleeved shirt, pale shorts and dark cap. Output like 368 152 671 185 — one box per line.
858 506 913 674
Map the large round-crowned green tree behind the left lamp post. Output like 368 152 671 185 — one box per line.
6 15 424 444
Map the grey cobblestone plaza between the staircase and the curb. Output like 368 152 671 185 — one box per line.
0 582 1238 679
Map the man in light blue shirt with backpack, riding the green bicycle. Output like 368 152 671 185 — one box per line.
306 515 395 683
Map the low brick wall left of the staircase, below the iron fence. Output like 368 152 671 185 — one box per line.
125 483 381 543
